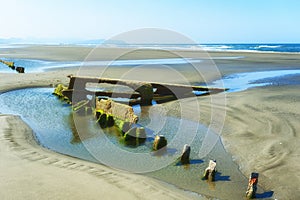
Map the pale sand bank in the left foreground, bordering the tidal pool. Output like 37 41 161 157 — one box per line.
0 115 204 200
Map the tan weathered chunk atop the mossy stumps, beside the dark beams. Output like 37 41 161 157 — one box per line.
96 99 138 123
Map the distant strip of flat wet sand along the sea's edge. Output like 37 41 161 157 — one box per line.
0 44 300 61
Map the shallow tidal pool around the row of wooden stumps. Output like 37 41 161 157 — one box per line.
0 88 252 199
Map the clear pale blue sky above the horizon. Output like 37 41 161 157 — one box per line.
0 0 300 43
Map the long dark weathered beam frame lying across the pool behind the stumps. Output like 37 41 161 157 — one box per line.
65 76 226 105
